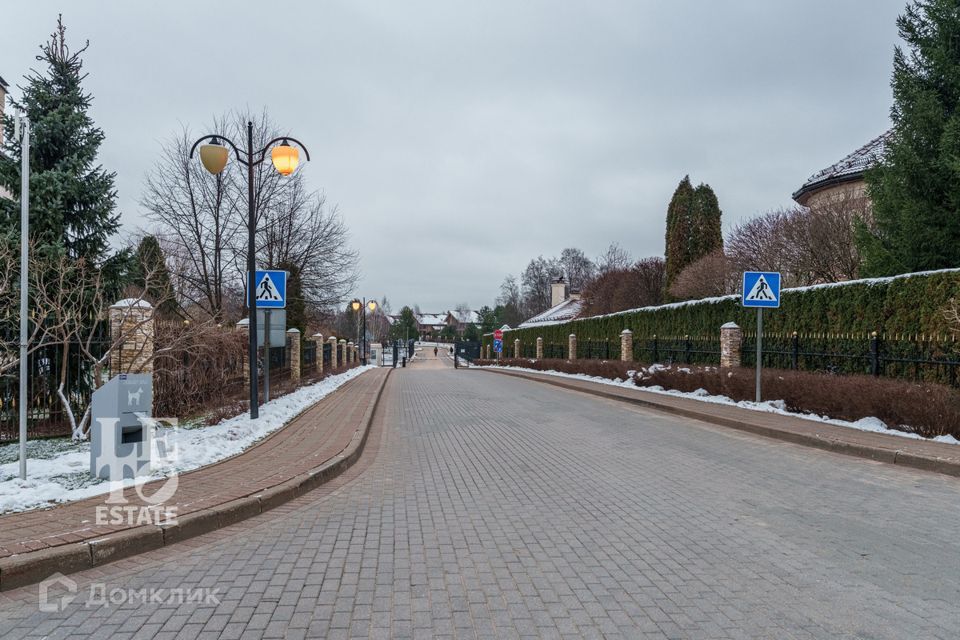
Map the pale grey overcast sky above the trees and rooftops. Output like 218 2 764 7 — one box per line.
0 0 905 311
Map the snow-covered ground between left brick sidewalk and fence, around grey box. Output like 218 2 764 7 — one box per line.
0 366 375 513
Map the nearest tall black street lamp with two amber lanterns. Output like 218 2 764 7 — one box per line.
190 122 310 419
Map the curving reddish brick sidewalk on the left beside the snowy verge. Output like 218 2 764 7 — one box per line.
0 369 389 568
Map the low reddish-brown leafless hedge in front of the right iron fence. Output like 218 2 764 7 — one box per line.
634 367 960 438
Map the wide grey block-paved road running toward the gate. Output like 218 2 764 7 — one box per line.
0 363 960 639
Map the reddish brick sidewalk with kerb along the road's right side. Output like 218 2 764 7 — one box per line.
473 368 960 476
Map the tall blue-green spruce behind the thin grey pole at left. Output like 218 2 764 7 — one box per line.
0 18 119 265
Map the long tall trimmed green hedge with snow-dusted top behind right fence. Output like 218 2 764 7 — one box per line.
483 269 960 354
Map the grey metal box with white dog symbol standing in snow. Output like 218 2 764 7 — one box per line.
90 373 153 480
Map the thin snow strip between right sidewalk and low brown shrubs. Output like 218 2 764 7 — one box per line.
484 365 960 444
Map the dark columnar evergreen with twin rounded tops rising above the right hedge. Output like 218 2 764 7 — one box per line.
666 176 723 290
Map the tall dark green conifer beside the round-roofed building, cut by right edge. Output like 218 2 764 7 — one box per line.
858 0 960 276
